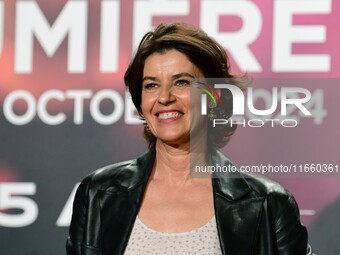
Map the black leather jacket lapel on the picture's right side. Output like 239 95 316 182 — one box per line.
212 152 265 255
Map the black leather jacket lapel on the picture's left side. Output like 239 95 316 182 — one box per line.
99 149 155 255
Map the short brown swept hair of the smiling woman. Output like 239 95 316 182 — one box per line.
124 23 242 149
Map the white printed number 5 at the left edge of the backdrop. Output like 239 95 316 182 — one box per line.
0 182 38 228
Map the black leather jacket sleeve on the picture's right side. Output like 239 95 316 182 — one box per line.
268 193 313 255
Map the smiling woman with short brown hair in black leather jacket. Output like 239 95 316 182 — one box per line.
67 23 311 255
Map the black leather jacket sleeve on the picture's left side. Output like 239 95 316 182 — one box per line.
66 178 88 255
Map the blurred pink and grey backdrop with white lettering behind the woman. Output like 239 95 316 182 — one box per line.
0 0 340 255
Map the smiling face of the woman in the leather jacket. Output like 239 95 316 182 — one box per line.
142 50 204 144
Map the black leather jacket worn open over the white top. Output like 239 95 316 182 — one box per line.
66 148 312 255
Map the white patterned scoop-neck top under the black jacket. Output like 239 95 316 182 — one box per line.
125 216 222 255
